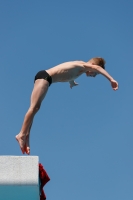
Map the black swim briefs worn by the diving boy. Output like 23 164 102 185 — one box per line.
34 70 52 86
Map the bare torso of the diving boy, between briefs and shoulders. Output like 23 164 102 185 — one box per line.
46 61 86 83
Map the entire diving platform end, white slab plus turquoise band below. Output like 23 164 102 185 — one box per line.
0 156 39 200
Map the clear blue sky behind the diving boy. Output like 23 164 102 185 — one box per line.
0 0 133 200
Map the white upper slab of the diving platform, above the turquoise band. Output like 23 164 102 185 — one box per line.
0 156 39 186
